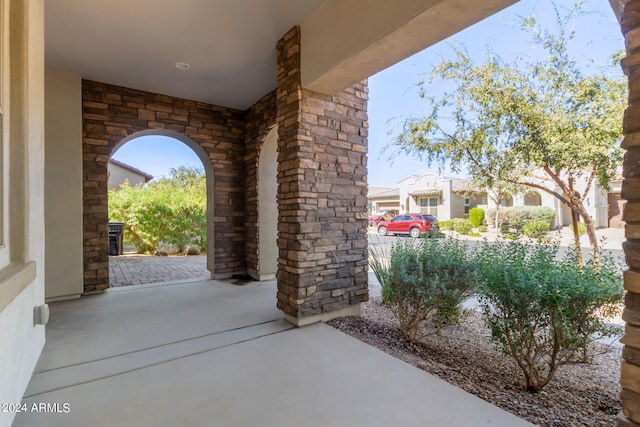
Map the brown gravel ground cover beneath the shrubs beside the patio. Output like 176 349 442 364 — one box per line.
329 297 621 427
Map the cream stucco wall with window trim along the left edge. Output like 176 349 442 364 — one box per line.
0 0 45 427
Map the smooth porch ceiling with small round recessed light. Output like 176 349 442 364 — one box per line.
45 0 325 110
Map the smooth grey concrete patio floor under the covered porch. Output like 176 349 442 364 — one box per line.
13 280 530 427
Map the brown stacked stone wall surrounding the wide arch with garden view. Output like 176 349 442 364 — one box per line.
82 81 245 292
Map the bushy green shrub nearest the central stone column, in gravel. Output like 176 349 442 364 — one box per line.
370 238 476 342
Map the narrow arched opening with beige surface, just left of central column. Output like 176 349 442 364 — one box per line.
254 127 278 280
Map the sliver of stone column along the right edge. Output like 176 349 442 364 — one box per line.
618 0 640 426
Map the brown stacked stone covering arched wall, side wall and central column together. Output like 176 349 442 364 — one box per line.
83 27 368 324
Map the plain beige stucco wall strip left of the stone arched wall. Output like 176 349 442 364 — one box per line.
44 69 83 299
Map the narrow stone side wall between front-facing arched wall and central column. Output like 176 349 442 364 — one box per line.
244 91 277 278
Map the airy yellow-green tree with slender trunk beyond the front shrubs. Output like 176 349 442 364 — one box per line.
391 5 626 252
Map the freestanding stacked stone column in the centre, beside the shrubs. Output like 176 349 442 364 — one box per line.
277 27 368 325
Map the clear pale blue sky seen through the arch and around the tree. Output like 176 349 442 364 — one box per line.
113 0 624 187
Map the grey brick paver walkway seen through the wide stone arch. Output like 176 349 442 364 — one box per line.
109 255 211 287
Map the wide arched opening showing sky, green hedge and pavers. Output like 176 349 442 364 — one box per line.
108 129 214 286
